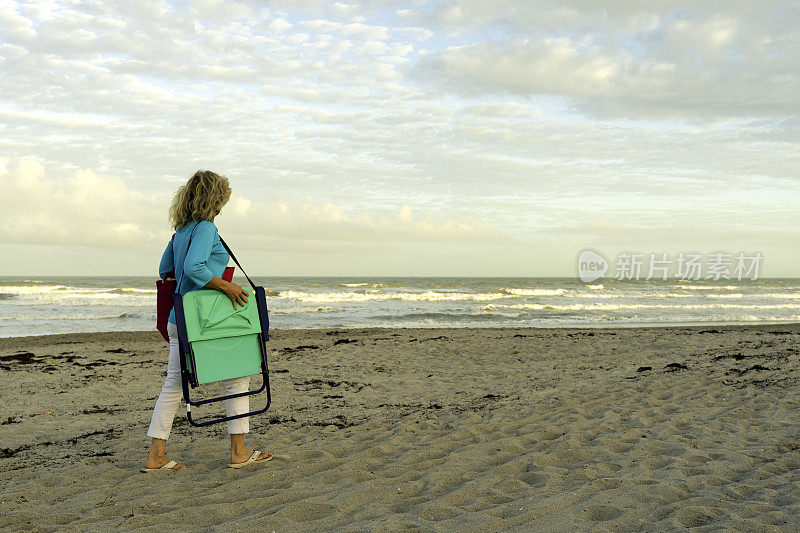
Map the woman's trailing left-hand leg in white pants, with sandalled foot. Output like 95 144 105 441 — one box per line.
145 322 186 468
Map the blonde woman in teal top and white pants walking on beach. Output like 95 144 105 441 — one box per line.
145 170 272 472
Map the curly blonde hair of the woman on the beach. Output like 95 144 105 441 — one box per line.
169 170 231 231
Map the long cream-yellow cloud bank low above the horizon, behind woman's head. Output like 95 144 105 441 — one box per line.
0 158 508 254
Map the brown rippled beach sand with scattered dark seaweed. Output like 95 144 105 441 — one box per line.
0 325 800 531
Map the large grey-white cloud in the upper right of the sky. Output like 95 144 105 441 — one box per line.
414 1 800 121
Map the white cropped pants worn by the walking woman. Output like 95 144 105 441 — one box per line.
147 322 250 440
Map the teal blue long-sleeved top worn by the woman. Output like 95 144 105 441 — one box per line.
158 220 230 324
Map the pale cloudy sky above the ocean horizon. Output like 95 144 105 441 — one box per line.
0 0 800 277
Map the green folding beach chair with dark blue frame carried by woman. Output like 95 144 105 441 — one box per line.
173 239 272 426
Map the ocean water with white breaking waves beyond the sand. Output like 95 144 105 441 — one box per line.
0 276 800 337
